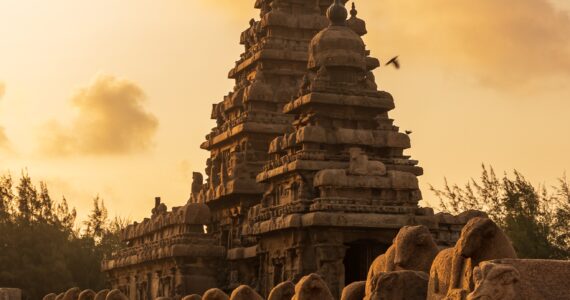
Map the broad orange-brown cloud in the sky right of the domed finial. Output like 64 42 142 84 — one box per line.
368 0 570 88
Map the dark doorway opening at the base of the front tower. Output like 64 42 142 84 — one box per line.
343 240 389 286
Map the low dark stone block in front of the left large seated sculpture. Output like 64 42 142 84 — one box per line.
364 270 429 300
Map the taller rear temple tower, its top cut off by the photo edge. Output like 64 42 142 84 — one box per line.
190 0 346 287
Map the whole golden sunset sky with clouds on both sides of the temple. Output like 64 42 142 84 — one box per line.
0 0 570 220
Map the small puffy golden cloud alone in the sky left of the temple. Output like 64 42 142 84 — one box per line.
40 75 158 156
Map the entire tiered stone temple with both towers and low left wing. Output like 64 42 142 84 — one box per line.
102 0 474 300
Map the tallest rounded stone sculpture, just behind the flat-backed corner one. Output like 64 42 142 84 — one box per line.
428 217 517 299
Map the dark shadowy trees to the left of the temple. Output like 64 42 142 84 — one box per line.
0 173 126 299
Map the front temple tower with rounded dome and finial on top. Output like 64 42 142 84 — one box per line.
248 1 437 298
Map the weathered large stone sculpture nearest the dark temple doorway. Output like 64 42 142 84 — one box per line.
366 225 439 295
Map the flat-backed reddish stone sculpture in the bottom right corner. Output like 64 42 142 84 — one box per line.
467 259 570 300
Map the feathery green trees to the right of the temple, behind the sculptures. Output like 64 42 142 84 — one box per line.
431 165 570 259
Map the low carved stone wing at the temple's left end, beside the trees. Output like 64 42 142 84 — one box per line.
101 198 225 300
